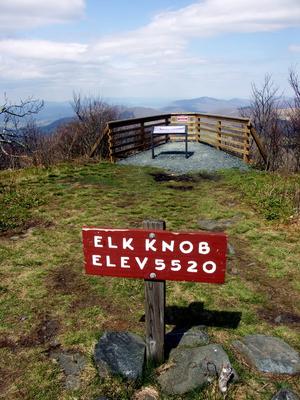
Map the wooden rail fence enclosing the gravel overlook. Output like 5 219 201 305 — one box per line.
91 113 266 163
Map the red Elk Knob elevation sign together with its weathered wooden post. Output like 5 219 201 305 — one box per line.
82 221 227 363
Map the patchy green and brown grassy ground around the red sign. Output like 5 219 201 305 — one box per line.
0 163 300 400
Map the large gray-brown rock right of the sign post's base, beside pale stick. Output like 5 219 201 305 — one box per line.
158 344 237 394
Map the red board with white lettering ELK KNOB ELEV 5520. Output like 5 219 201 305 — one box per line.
82 227 227 283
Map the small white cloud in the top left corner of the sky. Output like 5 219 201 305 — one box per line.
0 0 85 34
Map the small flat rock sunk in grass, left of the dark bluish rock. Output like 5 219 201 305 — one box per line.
50 351 86 390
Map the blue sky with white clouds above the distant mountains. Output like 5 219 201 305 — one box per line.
0 0 300 105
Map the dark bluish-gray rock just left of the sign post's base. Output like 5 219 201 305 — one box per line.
94 332 145 379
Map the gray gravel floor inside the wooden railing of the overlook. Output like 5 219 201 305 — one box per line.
118 142 248 173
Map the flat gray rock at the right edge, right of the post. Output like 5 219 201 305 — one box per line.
233 335 300 375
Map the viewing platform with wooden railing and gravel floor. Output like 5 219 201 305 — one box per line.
90 113 267 171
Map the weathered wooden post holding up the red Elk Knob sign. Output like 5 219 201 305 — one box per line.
143 220 166 364
